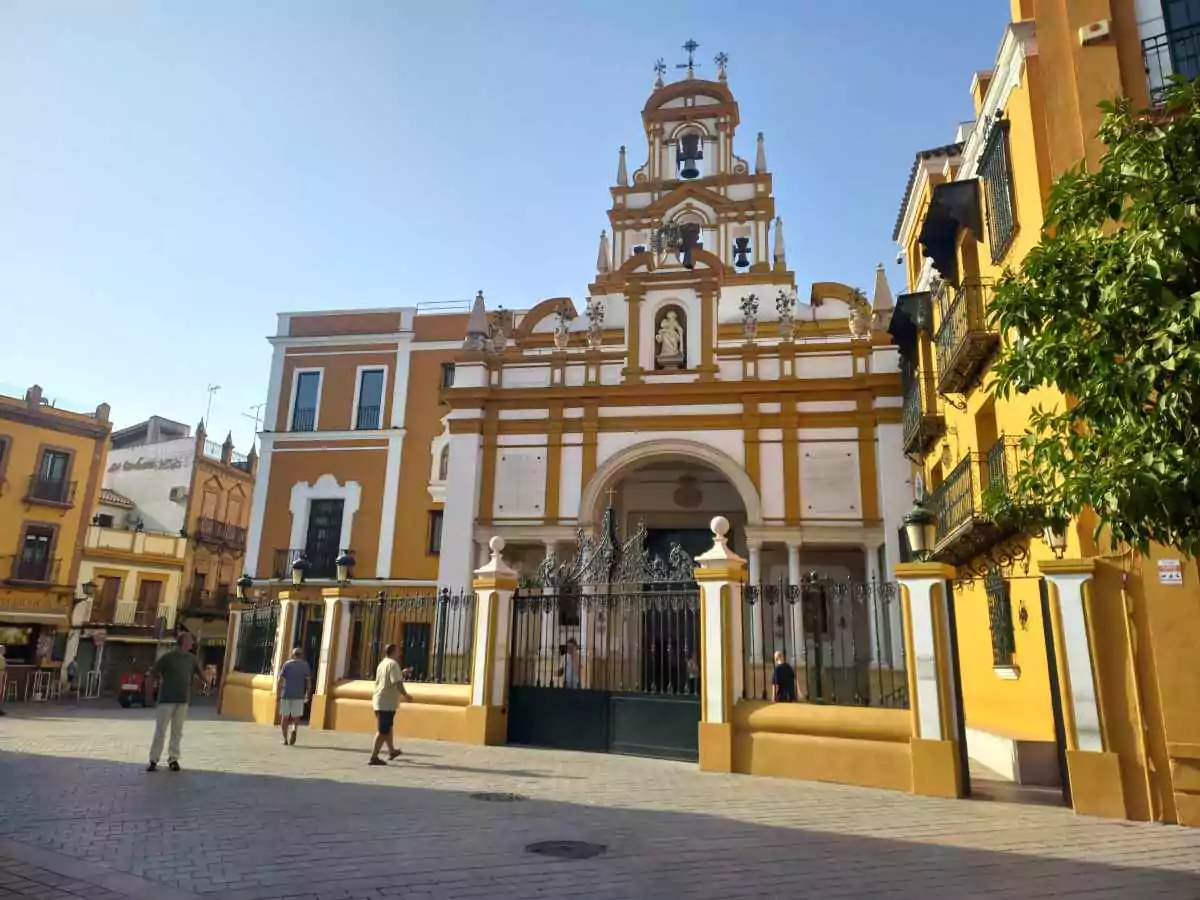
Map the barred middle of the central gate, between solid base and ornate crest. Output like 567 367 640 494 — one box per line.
512 584 701 696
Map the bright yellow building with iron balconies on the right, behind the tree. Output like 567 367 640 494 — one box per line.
892 0 1200 824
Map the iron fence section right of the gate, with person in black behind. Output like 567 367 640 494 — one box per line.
742 577 908 709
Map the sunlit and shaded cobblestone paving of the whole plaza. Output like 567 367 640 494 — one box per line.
0 707 1200 900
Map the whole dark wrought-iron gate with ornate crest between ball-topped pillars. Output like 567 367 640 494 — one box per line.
509 508 701 760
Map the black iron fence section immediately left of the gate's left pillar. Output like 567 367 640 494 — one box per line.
346 588 475 684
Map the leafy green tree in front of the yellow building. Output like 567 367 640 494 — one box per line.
990 79 1200 556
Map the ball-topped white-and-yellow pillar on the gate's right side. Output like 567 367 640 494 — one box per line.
696 516 746 772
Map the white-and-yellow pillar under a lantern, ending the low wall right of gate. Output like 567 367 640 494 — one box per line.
895 563 962 797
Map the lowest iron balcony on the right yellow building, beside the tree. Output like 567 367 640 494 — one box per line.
930 437 1019 565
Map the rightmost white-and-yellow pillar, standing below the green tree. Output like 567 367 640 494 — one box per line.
1038 559 1128 818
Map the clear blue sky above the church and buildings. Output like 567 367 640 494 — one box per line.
0 0 1009 449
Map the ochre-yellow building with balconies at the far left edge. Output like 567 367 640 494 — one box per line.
0 384 110 691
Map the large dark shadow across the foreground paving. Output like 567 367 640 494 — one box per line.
0 745 1200 900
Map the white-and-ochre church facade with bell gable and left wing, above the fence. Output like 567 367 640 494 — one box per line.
247 58 912 609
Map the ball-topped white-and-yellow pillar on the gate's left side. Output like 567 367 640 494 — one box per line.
467 535 517 744
